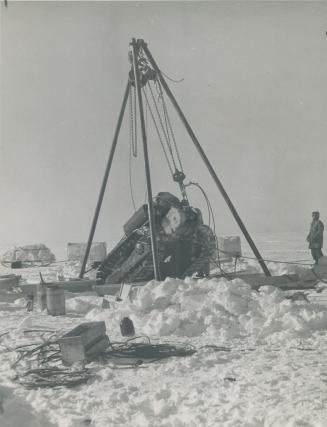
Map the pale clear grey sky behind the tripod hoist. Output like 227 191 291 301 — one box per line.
0 0 327 252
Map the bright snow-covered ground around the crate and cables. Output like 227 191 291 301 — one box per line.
0 236 327 427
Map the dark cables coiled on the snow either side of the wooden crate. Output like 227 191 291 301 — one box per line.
11 337 197 389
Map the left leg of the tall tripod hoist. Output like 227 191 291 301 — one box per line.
79 81 129 278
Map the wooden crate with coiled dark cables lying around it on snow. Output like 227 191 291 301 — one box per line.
12 322 196 388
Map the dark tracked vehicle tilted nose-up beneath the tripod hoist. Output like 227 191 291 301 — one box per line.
97 193 216 283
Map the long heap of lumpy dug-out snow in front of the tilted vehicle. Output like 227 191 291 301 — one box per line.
75 278 327 342
